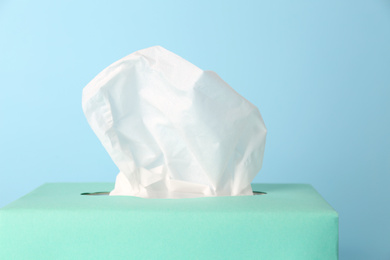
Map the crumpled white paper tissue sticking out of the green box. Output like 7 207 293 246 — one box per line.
82 46 266 198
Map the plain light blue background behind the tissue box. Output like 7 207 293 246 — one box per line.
0 0 390 259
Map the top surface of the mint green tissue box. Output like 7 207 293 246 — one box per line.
1 183 337 215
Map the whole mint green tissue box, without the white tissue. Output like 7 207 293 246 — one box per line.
0 183 338 260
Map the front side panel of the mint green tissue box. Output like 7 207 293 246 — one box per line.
0 211 337 259
